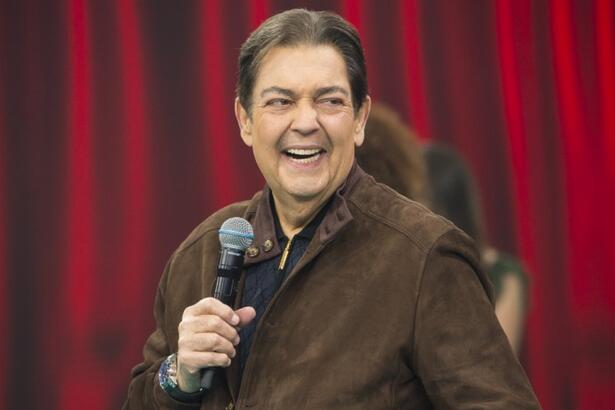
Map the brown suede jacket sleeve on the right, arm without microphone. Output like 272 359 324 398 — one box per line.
412 229 540 410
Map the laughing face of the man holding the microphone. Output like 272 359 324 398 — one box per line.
235 46 370 207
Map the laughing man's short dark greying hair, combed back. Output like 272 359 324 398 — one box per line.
237 9 367 113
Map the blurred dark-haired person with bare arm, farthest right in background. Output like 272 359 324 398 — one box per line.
423 144 528 355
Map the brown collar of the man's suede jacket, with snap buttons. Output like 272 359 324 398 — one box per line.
244 161 365 266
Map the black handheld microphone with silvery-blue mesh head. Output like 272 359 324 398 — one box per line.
201 217 254 390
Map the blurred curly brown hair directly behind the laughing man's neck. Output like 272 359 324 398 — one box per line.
355 103 427 203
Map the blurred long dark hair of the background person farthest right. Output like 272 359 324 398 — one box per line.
423 144 484 246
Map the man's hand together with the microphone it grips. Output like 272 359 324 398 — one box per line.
177 218 256 392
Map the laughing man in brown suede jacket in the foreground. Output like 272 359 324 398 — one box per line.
126 10 539 409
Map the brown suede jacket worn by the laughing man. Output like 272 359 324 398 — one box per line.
125 165 540 410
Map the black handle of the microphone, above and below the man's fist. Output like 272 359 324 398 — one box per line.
201 248 243 390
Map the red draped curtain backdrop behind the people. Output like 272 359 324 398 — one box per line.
0 0 615 410
